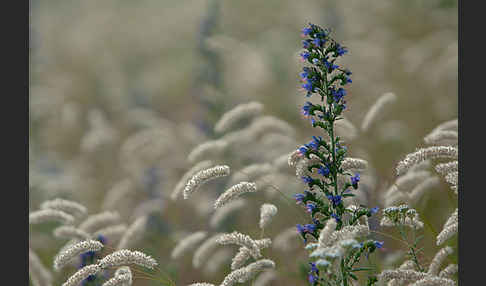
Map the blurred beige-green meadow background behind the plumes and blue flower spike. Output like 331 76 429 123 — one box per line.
29 0 458 285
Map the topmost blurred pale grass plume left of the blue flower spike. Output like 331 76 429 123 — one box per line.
214 101 263 133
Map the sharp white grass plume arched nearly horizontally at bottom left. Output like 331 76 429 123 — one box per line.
98 249 158 269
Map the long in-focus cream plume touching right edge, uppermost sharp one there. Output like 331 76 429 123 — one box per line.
396 146 458 176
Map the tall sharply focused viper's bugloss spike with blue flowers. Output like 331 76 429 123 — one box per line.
295 24 383 286
